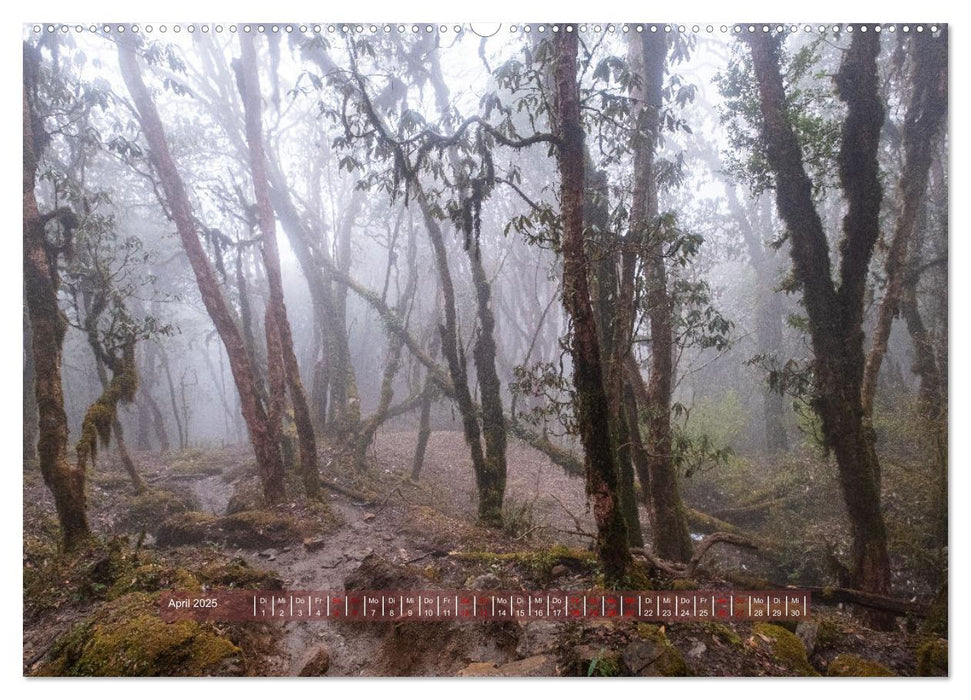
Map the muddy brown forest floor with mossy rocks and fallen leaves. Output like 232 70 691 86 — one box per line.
23 432 947 676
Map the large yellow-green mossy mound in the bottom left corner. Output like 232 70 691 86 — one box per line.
37 593 240 676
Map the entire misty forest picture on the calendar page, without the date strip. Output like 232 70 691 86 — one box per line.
23 24 949 676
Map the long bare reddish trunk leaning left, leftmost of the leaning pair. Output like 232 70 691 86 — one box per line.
118 36 286 504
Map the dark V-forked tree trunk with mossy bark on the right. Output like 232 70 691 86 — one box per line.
747 32 890 593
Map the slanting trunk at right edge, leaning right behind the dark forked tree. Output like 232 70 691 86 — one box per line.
862 28 947 421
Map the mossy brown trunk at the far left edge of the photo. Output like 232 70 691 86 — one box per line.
23 85 90 550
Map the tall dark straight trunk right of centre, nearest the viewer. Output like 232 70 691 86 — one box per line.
554 25 631 586
